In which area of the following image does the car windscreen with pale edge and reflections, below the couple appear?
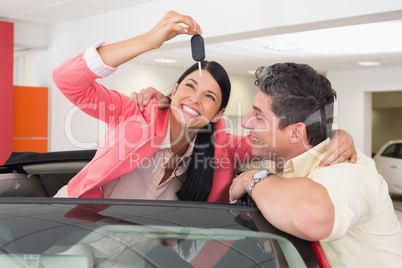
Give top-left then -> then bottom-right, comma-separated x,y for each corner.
70,225 -> 306,268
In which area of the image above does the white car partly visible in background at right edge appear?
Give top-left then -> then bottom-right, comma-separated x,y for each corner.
373,140 -> 402,194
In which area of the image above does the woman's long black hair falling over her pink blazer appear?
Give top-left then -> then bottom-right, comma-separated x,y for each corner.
176,61 -> 231,201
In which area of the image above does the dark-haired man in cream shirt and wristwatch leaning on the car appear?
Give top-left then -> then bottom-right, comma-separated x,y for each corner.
230,63 -> 402,267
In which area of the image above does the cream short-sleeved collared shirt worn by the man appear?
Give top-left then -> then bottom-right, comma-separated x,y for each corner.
271,139 -> 402,268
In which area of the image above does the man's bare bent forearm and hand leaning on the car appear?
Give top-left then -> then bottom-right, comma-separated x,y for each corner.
230,170 -> 335,241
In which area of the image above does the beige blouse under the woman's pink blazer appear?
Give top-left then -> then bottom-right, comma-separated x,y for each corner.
103,118 -> 195,200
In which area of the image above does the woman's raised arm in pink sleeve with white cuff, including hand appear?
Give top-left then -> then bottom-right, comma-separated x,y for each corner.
53,11 -> 201,123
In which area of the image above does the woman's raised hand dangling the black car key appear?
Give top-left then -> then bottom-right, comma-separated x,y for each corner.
145,10 -> 202,49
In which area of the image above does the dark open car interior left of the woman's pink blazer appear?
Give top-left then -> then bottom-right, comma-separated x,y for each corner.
0,150 -> 96,197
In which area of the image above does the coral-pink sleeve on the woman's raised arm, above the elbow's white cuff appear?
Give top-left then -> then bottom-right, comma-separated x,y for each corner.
53,53 -> 137,123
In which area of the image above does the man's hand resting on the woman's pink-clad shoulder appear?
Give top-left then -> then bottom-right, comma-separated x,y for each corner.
131,87 -> 170,112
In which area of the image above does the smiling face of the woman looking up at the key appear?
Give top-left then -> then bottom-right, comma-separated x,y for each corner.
171,70 -> 225,129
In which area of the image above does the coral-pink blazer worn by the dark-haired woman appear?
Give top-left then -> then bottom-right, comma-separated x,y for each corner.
53,51 -> 251,202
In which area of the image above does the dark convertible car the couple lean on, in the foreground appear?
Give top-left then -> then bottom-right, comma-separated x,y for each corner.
0,151 -> 330,268
